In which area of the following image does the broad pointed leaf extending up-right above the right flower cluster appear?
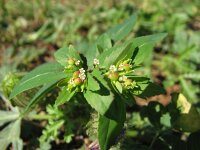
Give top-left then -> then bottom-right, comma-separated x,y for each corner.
98,33 -> 166,67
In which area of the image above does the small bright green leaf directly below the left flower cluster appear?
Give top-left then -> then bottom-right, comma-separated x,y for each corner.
55,87 -> 76,106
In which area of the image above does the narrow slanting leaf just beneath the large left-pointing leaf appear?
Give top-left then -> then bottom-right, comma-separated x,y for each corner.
23,81 -> 57,114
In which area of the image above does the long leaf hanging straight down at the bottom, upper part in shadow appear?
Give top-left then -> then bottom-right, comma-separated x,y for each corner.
98,96 -> 126,150
